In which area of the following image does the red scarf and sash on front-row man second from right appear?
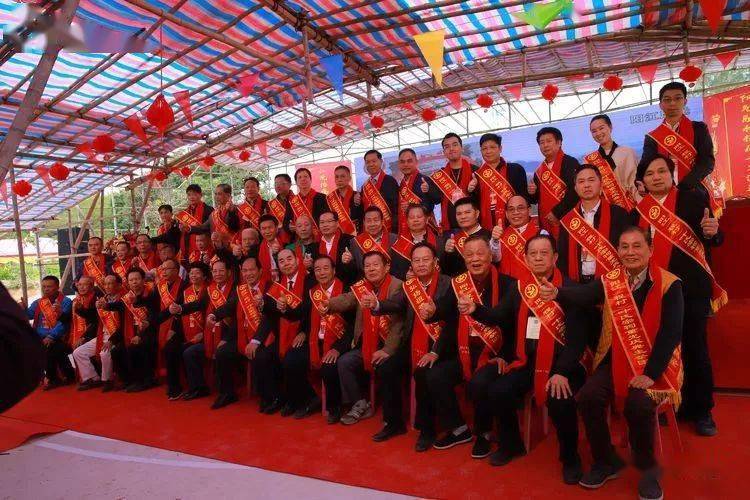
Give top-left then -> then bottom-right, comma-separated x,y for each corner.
509,269 -> 565,404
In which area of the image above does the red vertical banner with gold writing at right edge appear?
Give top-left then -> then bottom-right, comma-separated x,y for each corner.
703,86 -> 750,199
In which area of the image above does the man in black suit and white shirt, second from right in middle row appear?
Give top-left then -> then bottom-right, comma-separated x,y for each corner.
557,164 -> 632,283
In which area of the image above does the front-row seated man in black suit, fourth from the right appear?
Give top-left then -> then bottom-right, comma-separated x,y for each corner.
372,241 -> 453,452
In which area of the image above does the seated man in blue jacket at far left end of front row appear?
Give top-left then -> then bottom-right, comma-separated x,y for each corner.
26,276 -> 76,390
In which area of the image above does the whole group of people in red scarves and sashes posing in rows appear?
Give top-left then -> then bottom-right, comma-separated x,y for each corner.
28,83 -> 726,498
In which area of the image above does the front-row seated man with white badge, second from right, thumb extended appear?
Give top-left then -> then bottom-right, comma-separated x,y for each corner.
458,234 -> 596,484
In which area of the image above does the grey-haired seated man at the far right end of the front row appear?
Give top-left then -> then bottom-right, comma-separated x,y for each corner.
540,227 -> 684,499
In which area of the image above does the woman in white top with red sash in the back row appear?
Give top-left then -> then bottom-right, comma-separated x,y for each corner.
583,115 -> 641,206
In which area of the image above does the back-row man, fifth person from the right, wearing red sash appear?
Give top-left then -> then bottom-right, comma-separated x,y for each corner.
431,132 -> 479,232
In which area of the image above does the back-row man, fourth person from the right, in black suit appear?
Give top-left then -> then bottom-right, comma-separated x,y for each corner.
468,134 -> 530,231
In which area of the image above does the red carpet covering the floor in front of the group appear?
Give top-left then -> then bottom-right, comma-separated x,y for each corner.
0,388 -> 750,499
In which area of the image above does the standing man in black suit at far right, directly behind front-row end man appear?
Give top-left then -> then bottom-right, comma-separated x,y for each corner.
636,155 -> 724,436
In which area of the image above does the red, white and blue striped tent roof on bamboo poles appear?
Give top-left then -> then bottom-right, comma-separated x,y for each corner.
0,0 -> 750,229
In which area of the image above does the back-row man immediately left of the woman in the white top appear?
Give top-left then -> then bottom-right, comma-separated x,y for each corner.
528,127 -> 579,238
